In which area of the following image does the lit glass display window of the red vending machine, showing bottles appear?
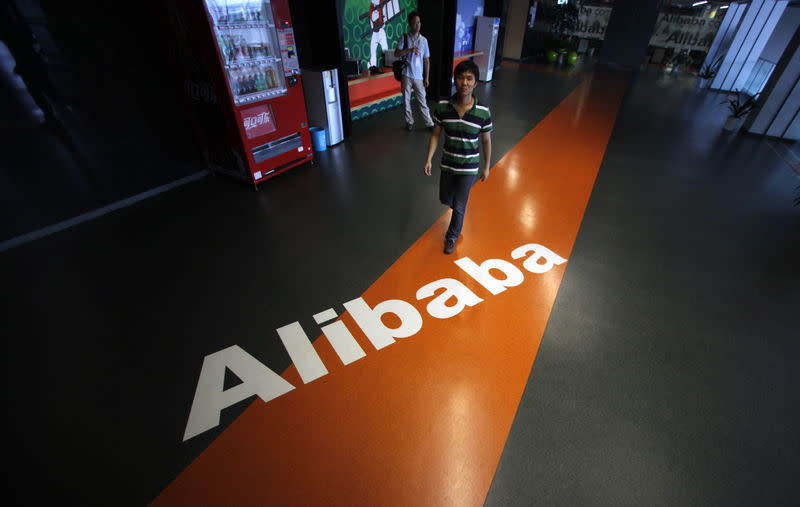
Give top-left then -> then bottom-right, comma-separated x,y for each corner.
205,0 -> 287,106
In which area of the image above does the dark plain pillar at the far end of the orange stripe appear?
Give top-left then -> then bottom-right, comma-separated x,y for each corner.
599,0 -> 664,69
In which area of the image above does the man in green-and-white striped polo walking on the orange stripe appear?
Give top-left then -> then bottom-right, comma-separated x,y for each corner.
424,60 -> 493,254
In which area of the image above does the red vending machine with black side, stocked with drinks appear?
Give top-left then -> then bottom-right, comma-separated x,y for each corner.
166,0 -> 313,185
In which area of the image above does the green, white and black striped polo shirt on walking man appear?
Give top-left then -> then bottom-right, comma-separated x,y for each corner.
433,95 -> 492,174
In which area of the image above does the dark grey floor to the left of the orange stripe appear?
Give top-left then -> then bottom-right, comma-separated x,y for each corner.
0,64 -> 580,505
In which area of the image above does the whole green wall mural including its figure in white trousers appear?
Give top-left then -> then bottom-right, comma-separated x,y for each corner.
342,0 -> 418,69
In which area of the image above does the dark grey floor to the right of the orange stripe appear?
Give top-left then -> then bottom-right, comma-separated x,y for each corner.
486,71 -> 800,505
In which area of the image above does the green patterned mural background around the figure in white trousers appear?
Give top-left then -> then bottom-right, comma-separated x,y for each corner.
342,0 -> 417,67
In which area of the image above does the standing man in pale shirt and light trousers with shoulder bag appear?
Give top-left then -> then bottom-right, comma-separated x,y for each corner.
394,11 -> 433,130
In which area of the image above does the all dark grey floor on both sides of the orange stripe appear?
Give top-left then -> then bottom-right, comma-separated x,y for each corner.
0,68 -> 800,505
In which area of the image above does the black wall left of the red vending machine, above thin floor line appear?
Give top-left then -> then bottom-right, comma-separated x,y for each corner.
0,0 -> 204,240
